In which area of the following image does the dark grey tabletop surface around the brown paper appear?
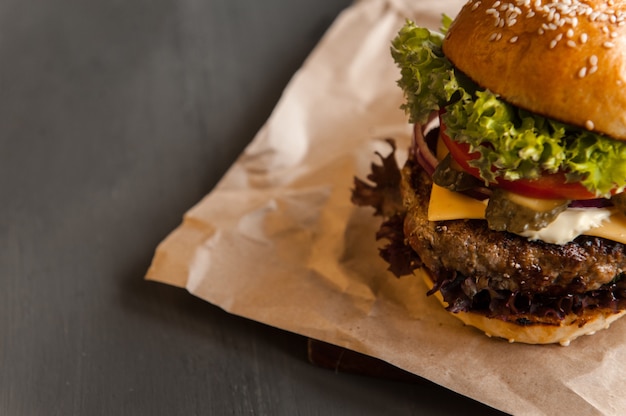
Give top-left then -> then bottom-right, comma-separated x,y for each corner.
0,0 -> 504,416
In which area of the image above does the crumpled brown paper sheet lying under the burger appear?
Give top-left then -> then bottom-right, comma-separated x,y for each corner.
147,0 -> 626,415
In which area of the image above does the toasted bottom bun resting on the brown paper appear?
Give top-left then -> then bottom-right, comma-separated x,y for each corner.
415,268 -> 626,346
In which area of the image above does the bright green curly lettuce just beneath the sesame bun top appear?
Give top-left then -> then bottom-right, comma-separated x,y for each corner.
391,18 -> 626,197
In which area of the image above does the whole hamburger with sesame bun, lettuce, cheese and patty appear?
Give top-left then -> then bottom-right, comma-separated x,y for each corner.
352,0 -> 626,345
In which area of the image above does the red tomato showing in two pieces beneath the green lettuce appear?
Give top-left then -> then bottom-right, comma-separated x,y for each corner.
439,119 -> 597,200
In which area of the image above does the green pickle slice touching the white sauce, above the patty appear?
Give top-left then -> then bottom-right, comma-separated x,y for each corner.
485,189 -> 571,234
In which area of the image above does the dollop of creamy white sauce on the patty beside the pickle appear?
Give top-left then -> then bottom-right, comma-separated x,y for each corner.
520,208 -> 611,244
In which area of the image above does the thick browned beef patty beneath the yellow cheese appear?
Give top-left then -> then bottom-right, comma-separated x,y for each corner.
401,161 -> 626,295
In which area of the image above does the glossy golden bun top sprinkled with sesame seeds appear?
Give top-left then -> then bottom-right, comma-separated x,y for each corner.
443,0 -> 626,140
